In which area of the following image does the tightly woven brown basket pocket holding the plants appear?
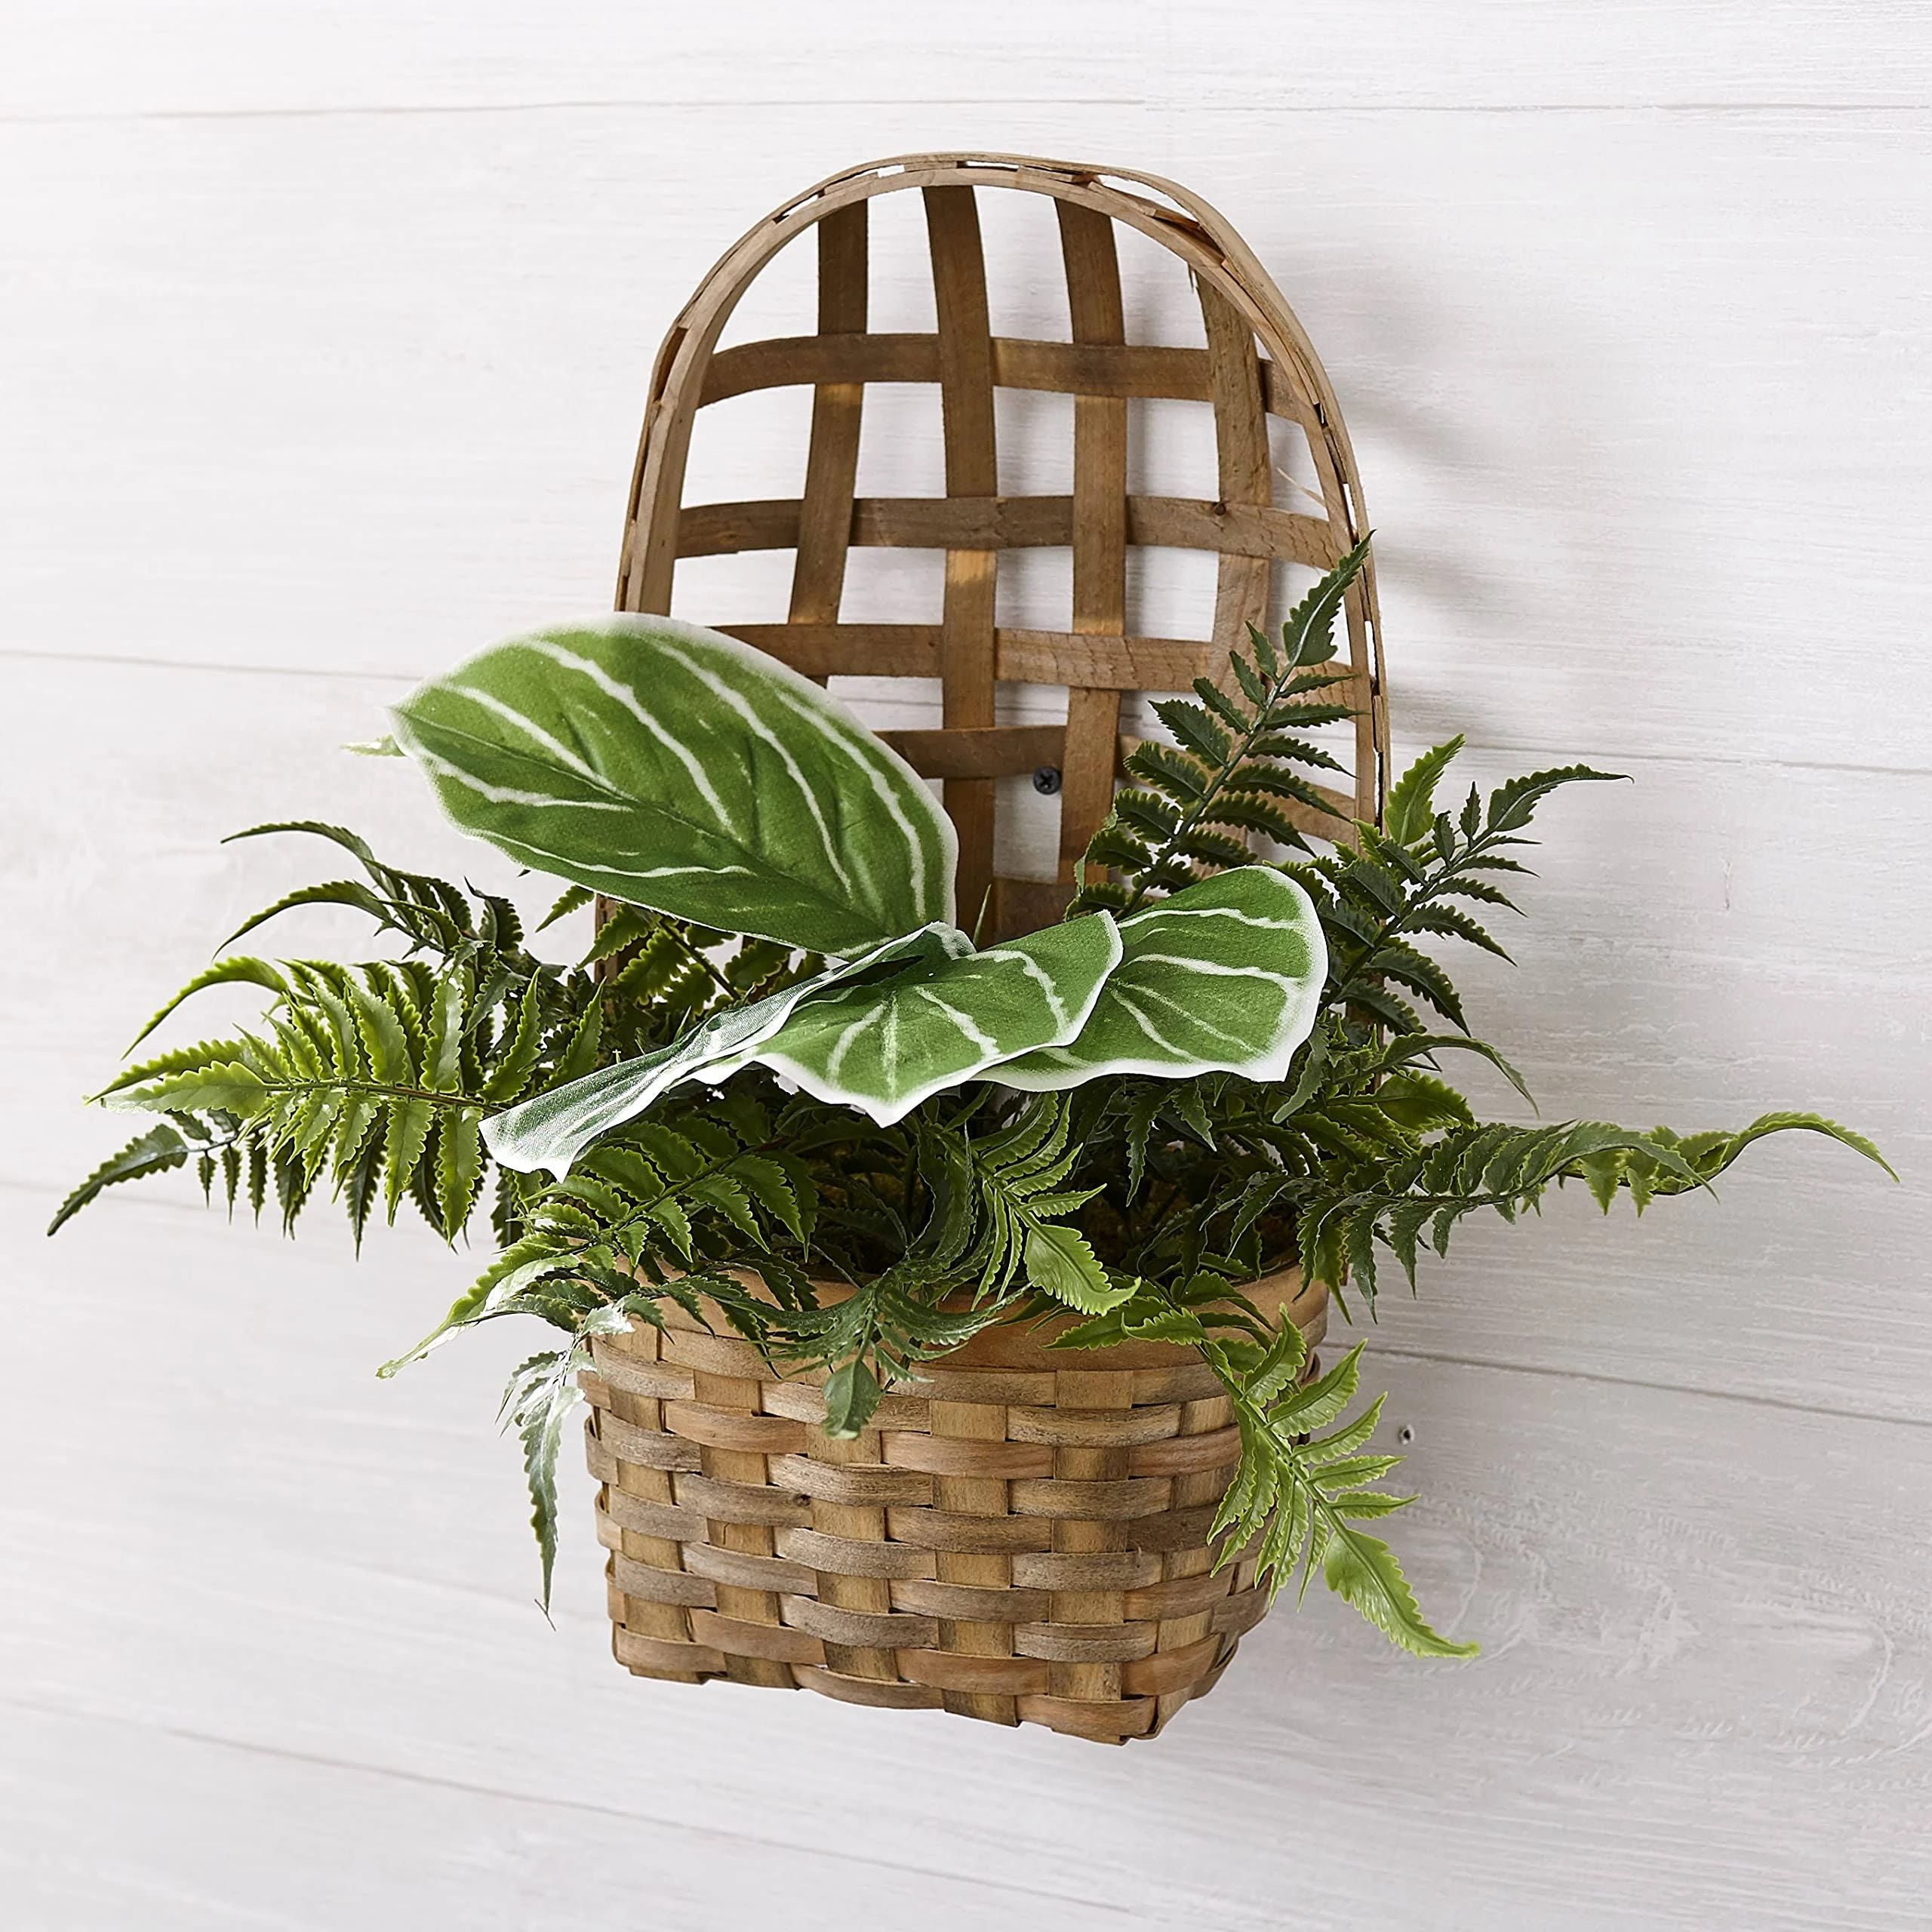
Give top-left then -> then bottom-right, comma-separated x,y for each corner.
583,1273 -> 1325,1743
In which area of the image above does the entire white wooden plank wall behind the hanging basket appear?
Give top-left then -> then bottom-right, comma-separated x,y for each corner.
0,0 -> 1932,1932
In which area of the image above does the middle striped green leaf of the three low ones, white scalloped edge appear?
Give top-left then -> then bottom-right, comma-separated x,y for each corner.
740,912 -> 1121,1126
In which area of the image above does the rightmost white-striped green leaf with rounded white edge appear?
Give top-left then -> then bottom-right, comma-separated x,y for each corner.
995,866 -> 1327,1091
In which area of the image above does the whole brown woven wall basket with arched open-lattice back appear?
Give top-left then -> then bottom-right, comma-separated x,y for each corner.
586,155 -> 1387,1743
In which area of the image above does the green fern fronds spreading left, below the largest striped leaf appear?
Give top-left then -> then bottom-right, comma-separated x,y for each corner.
51,823 -> 819,1244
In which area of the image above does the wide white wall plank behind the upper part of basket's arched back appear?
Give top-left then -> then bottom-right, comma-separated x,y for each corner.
0,106 -> 1932,771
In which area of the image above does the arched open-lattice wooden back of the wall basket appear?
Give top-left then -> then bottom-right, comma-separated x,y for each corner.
617,155 -> 1387,935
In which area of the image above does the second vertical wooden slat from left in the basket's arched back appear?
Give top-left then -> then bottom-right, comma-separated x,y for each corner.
925,187 -> 999,931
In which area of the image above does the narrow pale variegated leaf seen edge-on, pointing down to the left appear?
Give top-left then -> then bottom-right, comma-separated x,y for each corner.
483,924 -> 972,1179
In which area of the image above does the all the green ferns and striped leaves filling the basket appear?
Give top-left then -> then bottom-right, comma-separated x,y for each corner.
54,546 -> 1881,1656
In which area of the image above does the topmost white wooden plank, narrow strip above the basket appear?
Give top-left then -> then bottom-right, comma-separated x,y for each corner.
0,0 -> 1932,117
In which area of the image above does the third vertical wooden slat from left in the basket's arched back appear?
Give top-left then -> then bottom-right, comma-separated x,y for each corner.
1058,201 -> 1126,887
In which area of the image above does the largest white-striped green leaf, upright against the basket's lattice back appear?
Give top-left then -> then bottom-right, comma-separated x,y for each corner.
394,614 -> 956,958
